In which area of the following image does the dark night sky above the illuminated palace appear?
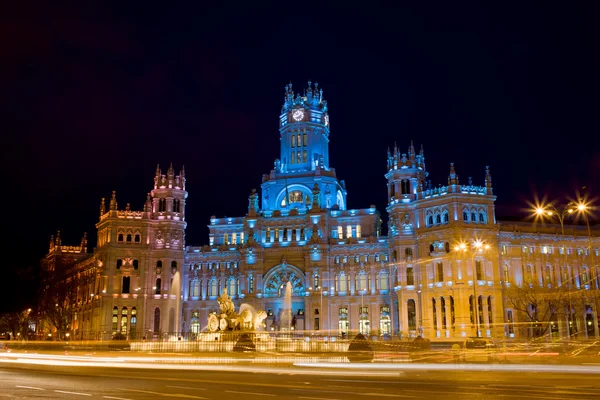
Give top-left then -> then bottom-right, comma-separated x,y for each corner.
0,2 -> 600,310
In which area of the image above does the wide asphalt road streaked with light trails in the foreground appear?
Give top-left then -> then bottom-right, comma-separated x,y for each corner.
0,363 -> 600,400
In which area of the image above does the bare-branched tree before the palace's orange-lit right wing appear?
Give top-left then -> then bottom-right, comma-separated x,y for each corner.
505,284 -> 570,338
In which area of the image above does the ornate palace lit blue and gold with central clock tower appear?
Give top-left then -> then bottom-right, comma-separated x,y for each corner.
46,82 -> 598,340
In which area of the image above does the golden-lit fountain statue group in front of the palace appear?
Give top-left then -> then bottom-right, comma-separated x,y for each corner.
208,288 -> 267,332
